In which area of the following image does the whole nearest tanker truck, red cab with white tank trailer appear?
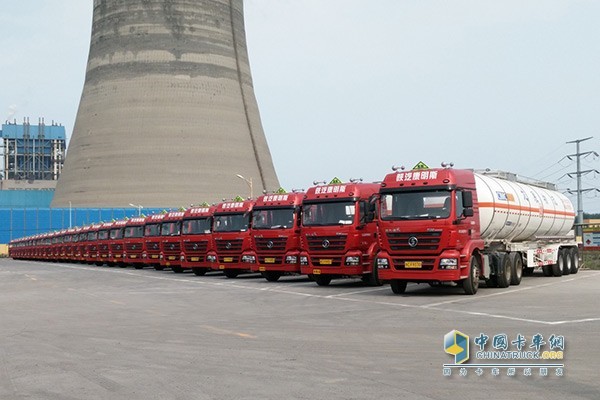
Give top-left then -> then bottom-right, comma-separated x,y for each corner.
377,164 -> 579,294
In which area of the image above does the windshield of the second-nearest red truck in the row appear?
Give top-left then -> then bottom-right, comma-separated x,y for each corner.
302,201 -> 356,226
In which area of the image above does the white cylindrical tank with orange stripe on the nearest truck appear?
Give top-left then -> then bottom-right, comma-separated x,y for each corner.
475,172 -> 575,242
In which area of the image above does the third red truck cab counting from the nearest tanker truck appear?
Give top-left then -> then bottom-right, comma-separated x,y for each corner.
242,193 -> 304,282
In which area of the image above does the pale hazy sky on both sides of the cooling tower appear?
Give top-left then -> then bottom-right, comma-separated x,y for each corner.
0,0 -> 600,212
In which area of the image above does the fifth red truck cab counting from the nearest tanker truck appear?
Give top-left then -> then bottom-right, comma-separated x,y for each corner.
181,206 -> 217,276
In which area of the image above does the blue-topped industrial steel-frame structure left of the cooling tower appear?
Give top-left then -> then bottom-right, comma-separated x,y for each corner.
0,118 -> 66,183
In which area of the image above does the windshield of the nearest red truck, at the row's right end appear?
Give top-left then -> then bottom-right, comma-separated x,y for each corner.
381,190 -> 451,220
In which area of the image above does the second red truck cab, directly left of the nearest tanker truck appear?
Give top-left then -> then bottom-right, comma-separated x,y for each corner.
299,180 -> 380,286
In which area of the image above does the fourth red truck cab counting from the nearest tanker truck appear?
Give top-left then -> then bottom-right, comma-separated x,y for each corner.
213,199 -> 254,278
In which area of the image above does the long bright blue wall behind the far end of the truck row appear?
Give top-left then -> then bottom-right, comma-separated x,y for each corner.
0,208 -> 163,244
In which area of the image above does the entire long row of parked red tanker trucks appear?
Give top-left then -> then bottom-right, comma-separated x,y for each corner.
9,166 -> 579,294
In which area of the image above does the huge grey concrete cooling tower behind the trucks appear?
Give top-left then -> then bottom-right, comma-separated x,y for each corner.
52,0 -> 279,207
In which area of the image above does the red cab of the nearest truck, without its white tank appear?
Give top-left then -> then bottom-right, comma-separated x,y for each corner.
377,169 -> 483,293
